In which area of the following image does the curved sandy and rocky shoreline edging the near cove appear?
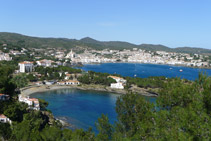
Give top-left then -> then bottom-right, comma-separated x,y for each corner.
20,84 -> 157,97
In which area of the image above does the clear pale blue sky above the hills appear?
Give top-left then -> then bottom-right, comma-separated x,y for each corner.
0,0 -> 211,49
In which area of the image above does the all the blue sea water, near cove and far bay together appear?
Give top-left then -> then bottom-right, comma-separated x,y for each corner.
32,63 -> 211,133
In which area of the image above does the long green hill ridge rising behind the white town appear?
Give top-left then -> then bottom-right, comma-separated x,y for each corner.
0,32 -> 211,53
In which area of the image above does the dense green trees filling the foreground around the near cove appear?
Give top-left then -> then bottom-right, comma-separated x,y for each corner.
0,65 -> 211,140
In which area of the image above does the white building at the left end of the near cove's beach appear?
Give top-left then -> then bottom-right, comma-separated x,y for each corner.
18,95 -> 40,110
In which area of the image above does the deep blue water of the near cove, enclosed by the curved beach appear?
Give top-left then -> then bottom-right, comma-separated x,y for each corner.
32,89 -> 155,132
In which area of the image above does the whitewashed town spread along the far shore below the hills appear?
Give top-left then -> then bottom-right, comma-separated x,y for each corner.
0,44 -> 211,68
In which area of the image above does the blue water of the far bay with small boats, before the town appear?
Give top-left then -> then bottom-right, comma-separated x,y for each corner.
81,63 -> 211,80
